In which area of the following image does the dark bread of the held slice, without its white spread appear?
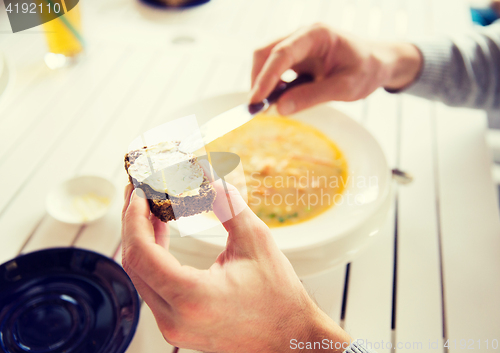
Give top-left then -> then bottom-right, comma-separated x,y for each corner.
125,146 -> 216,222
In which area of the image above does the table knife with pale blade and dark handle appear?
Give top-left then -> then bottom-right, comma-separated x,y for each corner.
179,74 -> 314,153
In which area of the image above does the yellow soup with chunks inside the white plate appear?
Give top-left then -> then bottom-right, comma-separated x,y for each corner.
206,114 -> 347,227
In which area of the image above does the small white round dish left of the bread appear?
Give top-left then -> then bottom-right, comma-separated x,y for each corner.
47,175 -> 116,224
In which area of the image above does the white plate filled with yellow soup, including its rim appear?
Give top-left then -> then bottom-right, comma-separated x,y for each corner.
166,93 -> 392,276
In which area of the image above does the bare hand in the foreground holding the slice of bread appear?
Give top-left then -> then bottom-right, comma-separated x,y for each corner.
122,179 -> 350,353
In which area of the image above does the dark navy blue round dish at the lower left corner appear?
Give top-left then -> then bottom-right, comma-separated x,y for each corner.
0,248 -> 140,353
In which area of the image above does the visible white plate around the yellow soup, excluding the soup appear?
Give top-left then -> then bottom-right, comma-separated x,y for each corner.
166,93 -> 392,275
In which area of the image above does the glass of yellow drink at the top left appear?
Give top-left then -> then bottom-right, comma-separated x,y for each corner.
42,0 -> 84,68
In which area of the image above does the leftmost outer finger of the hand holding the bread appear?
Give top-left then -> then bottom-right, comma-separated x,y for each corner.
122,189 -> 193,302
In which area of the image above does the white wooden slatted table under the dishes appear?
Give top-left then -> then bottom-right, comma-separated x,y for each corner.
0,0 -> 500,353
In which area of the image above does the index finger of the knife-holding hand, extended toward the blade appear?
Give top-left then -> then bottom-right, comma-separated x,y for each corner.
250,25 -> 333,103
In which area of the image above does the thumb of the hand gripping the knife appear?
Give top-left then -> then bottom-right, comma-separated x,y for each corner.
278,73 -> 358,115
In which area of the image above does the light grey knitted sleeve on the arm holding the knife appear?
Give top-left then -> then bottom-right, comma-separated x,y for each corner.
385,24 -> 500,109
